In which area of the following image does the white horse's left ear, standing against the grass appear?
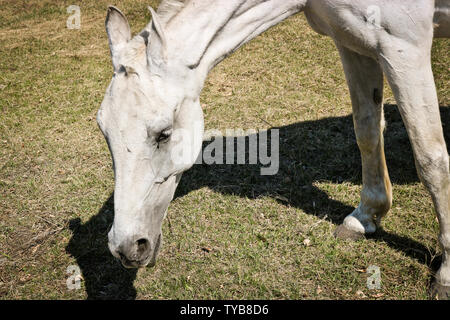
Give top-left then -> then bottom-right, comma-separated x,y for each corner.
105,6 -> 131,69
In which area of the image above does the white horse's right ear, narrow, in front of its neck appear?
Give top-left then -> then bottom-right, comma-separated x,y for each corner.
146,7 -> 167,65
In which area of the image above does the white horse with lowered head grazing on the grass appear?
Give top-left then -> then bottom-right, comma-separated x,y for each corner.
97,0 -> 450,298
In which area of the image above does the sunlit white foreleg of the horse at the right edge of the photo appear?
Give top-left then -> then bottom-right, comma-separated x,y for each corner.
380,40 -> 450,299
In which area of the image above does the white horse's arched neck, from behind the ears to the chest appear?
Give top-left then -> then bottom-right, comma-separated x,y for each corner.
161,0 -> 307,90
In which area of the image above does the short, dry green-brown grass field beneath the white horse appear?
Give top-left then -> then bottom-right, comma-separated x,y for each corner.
0,0 -> 450,299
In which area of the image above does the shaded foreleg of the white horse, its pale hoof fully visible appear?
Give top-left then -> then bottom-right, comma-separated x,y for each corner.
335,46 -> 392,239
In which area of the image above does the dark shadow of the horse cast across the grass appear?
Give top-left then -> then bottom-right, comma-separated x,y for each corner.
66,105 -> 450,299
